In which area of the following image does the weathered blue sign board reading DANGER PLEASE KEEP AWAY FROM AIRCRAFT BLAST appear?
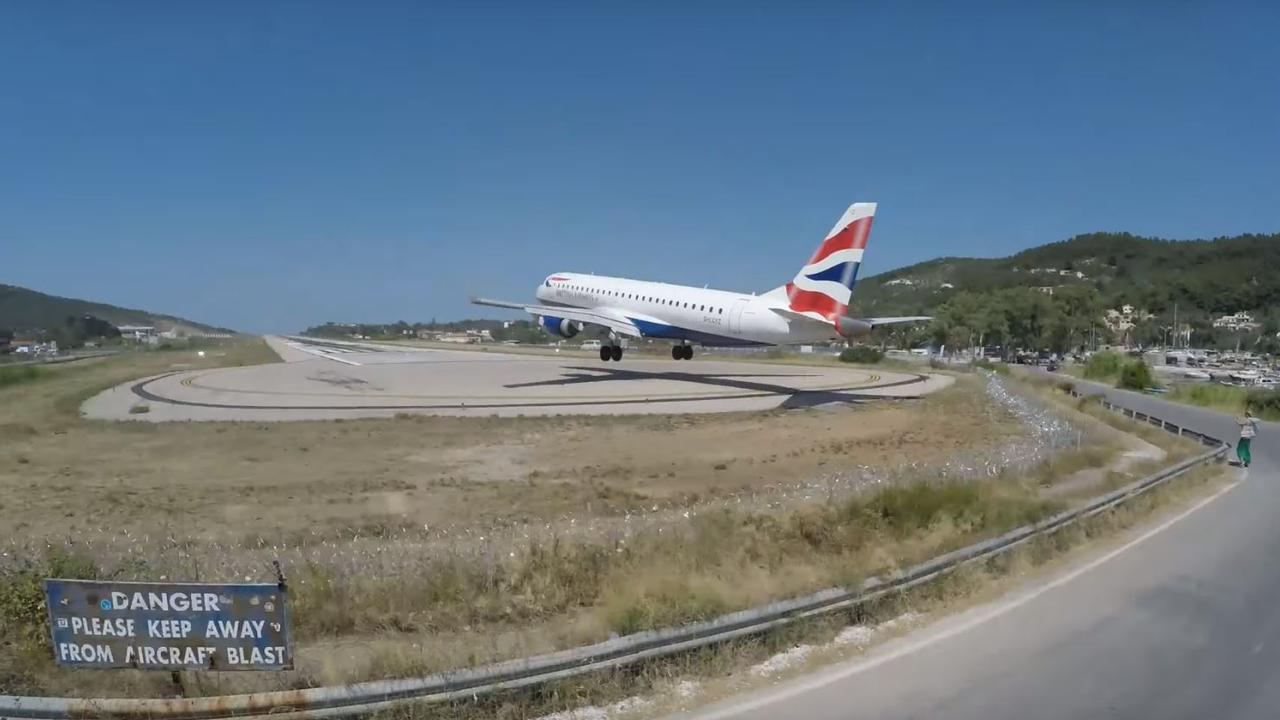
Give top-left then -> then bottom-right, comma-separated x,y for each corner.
45,579 -> 293,670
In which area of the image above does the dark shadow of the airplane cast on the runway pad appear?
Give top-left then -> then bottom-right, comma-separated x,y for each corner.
503,366 -> 924,410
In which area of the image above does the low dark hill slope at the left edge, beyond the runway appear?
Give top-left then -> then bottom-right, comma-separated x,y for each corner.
0,284 -> 232,334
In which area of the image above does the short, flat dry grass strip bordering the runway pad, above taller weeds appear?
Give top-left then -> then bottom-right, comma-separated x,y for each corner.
0,342 -> 1016,541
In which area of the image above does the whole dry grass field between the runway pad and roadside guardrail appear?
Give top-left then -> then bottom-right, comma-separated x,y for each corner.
0,341 -> 1192,696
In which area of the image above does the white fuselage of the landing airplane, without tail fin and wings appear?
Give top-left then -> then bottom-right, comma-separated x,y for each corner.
536,273 -> 840,346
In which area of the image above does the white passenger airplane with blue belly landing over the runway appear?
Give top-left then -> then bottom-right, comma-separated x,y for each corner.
471,202 -> 932,361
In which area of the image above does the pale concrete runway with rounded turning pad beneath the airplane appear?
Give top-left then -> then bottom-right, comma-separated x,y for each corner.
82,337 -> 951,421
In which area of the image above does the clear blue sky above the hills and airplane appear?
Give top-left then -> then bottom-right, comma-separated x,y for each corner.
0,1 -> 1280,331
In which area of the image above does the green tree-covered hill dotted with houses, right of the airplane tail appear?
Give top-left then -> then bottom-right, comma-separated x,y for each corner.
852,233 -> 1280,315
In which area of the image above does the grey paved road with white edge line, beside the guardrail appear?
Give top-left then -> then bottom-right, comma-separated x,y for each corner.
680,388 -> 1280,720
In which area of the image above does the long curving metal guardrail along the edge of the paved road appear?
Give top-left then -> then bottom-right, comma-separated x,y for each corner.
0,391 -> 1229,720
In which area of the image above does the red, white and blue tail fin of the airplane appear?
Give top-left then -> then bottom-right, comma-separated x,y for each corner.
787,202 -> 876,316
